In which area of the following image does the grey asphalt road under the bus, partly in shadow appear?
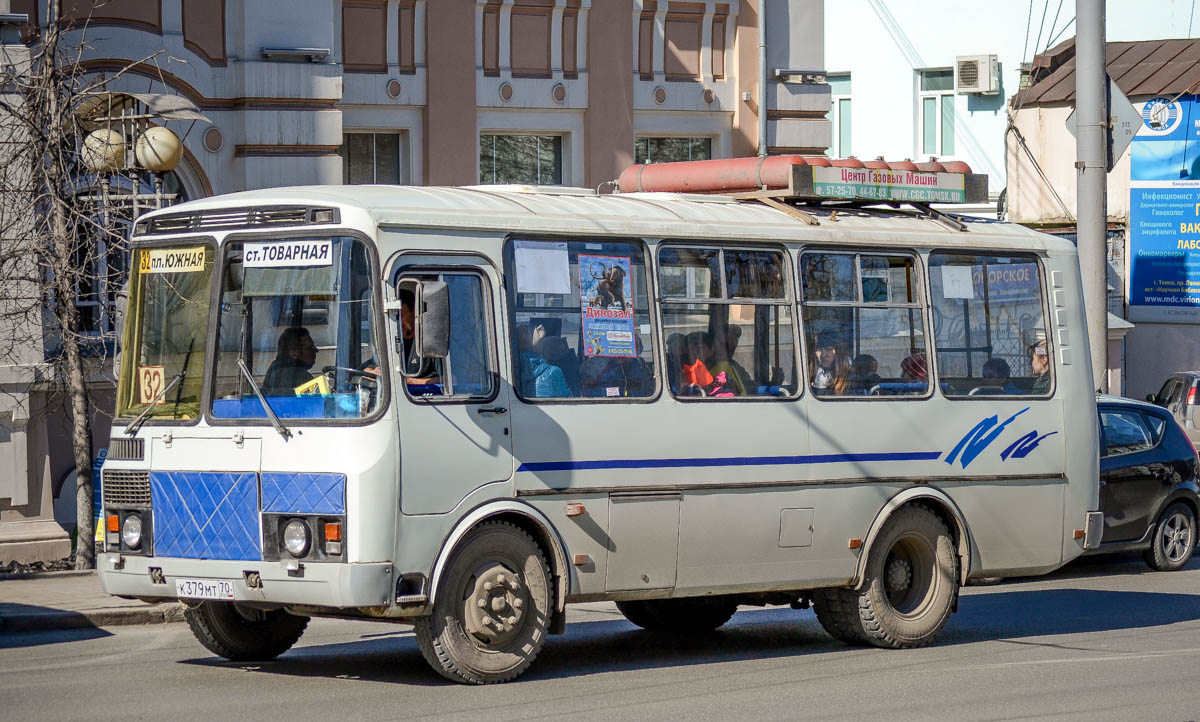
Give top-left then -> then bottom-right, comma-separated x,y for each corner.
0,555 -> 1200,722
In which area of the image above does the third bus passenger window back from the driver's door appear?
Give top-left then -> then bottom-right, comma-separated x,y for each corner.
800,252 -> 930,398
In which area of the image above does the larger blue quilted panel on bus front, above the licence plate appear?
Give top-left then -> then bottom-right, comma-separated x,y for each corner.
150,471 -> 263,561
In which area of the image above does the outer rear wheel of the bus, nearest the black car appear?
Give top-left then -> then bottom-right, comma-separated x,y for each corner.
858,505 -> 959,649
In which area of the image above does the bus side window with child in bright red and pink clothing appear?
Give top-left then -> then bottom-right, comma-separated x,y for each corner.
659,247 -> 797,398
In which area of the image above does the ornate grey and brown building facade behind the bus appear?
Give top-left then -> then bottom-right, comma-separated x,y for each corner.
0,0 -> 830,562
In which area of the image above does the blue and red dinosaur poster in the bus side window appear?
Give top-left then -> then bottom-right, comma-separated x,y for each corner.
580,254 -> 637,359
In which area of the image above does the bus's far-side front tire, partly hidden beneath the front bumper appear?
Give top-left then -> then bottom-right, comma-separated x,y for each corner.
184,602 -> 308,662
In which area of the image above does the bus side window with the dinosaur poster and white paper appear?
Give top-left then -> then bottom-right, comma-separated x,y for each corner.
506,240 -> 658,399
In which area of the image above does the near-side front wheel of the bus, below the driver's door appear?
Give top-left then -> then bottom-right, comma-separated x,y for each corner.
413,522 -> 552,685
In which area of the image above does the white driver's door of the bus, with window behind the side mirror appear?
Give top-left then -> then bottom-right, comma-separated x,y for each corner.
390,255 -> 512,515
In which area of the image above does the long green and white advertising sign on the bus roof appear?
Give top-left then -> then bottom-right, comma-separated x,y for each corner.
812,168 -> 967,203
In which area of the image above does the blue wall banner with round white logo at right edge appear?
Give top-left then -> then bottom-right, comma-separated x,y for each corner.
1129,95 -> 1200,323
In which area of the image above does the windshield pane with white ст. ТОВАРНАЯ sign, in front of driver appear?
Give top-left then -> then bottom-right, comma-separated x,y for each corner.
212,236 -> 380,419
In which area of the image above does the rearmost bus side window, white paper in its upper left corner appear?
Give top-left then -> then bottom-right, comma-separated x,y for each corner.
929,253 -> 1052,397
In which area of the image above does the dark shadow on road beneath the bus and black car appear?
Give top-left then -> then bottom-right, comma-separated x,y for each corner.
185,588 -> 1200,686
